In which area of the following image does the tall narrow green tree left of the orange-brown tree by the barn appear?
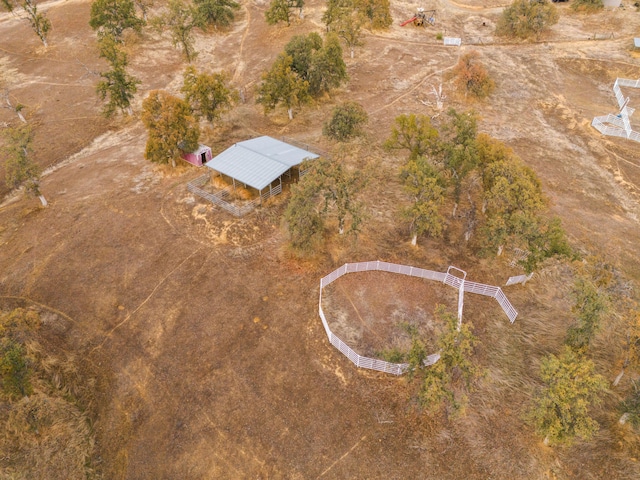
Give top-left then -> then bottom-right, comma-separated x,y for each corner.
96,35 -> 140,117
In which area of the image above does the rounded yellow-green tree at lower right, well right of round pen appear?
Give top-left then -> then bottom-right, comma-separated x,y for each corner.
527,346 -> 607,445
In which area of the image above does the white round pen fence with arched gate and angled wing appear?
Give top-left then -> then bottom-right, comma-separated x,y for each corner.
318,261 -> 518,375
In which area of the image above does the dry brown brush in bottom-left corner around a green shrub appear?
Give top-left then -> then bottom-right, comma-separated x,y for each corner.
0,308 -> 99,479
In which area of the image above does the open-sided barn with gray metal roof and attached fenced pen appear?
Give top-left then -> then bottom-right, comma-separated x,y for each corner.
187,136 -> 320,216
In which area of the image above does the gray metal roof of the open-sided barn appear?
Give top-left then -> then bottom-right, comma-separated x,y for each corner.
205,136 -> 319,190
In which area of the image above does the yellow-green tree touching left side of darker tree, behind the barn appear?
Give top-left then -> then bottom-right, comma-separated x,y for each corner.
256,53 -> 309,120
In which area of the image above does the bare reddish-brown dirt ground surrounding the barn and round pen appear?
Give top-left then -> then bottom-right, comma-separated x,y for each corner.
0,0 -> 640,479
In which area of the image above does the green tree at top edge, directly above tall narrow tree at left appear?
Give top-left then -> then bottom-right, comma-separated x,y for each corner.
89,0 -> 144,42
